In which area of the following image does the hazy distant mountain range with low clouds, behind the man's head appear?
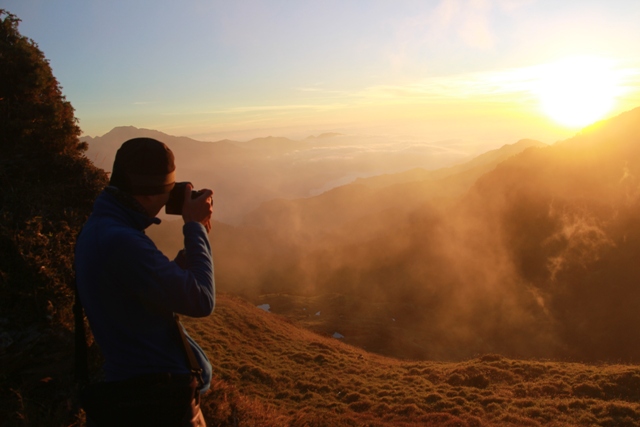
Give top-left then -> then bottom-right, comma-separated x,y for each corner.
82,126 -> 484,224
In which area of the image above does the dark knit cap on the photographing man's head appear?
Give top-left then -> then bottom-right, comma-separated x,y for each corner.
109,138 -> 176,195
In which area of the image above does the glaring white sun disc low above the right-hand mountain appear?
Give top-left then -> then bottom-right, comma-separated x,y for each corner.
536,56 -> 618,128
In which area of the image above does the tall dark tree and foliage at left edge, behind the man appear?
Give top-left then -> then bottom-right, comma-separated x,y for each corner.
0,9 -> 107,426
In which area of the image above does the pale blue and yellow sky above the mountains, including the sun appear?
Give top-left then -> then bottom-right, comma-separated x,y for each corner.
0,0 -> 640,148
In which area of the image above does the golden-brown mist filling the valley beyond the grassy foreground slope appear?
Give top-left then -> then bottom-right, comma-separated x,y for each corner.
110,110 -> 640,362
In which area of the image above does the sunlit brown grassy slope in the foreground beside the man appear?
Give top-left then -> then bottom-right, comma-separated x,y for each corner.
190,295 -> 640,426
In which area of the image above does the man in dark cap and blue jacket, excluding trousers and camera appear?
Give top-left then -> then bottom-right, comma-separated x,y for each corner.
75,138 -> 215,426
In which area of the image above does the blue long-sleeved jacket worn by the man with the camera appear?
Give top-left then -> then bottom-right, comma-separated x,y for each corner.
75,191 -> 215,391
